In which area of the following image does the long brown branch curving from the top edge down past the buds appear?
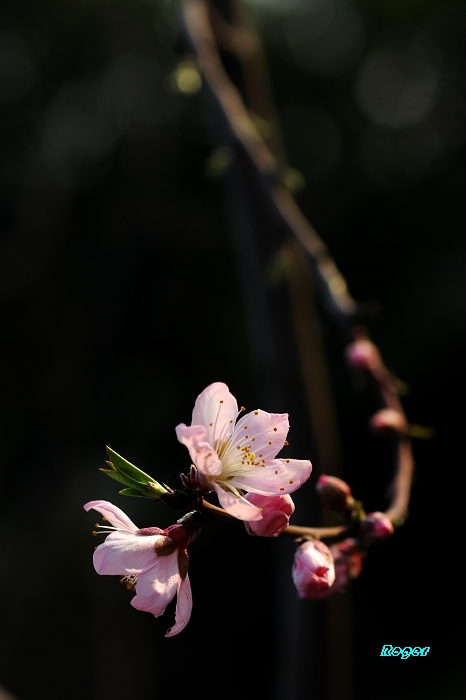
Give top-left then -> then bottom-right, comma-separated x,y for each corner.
183,0 -> 414,530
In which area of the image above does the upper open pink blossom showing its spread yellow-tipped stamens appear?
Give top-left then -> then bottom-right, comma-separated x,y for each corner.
176,382 -> 312,521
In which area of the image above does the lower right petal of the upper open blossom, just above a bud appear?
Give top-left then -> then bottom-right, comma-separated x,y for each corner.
230,459 -> 312,496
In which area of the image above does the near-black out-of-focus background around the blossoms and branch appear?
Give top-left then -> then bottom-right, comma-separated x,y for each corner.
0,0 -> 466,700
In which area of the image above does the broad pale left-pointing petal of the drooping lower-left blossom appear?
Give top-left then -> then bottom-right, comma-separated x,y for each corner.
94,532 -> 163,576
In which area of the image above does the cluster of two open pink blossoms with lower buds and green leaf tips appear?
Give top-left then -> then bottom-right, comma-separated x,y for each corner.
84,382 -> 393,637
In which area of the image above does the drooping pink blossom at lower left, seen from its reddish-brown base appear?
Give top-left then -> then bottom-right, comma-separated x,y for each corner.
84,501 -> 193,637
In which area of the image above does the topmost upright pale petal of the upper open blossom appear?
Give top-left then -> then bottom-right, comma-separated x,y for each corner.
191,382 -> 238,445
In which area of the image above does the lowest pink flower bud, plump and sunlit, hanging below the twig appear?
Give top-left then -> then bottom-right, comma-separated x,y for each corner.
292,540 -> 335,598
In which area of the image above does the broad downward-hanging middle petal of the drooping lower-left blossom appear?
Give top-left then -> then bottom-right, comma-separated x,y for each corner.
131,551 -> 180,617
